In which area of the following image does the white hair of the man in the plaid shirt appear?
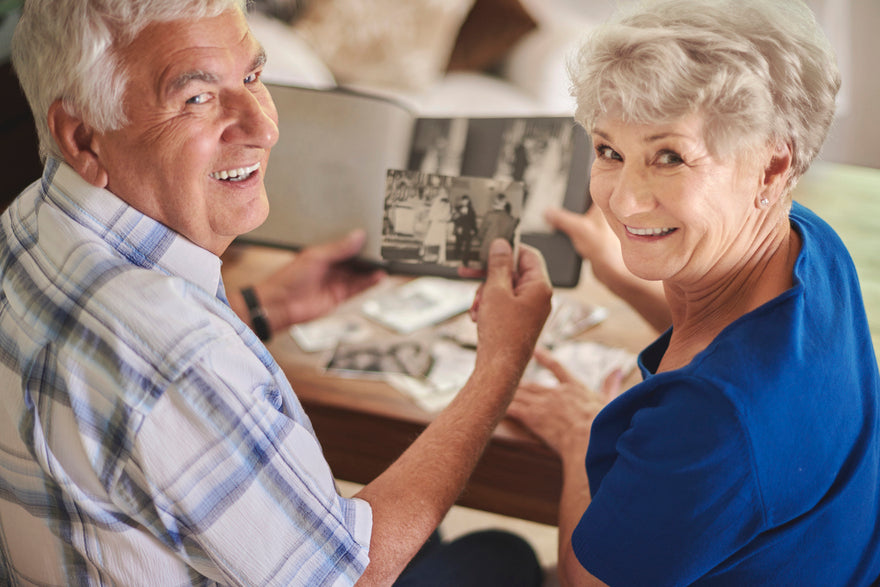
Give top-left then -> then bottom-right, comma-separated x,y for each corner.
12,0 -> 246,159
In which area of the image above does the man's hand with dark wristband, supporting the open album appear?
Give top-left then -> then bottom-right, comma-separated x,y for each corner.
230,230 -> 385,332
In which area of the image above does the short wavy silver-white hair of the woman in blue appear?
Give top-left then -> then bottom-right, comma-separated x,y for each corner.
569,0 -> 840,187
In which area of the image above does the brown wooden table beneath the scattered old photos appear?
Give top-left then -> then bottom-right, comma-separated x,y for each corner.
223,244 -> 655,525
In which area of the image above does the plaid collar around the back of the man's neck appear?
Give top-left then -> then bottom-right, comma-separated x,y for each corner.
43,159 -> 222,294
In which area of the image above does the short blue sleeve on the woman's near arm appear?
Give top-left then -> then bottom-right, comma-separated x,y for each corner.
572,378 -> 764,586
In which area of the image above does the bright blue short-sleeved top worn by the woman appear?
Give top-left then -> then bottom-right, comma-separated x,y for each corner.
572,204 -> 880,587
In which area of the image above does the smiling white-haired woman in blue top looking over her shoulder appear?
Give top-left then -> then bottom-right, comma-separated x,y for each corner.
510,0 -> 880,586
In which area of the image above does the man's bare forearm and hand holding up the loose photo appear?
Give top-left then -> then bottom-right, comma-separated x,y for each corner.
357,239 -> 553,585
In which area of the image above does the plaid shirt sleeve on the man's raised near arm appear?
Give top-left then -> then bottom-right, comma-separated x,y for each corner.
117,334 -> 372,585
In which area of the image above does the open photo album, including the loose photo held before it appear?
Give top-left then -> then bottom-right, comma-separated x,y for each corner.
239,84 -> 591,287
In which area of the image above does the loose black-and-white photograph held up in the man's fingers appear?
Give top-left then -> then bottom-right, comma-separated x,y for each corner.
381,170 -> 524,268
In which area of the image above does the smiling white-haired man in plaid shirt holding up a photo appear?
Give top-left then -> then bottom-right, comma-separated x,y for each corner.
0,0 -> 551,585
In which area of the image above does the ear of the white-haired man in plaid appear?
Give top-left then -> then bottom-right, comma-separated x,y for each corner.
49,99 -> 108,188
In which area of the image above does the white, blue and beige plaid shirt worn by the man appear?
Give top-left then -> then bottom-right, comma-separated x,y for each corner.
0,160 -> 372,586
